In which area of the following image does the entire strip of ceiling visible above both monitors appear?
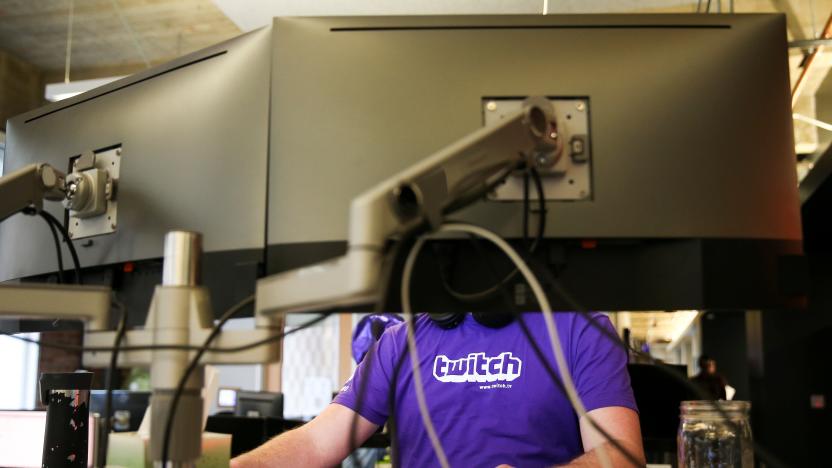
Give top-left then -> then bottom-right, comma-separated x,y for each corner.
0,0 -> 832,78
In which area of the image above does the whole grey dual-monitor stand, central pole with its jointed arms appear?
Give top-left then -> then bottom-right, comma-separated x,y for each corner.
6,98 -> 562,463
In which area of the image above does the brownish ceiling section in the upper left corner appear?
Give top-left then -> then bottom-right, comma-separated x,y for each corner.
0,0 -> 240,78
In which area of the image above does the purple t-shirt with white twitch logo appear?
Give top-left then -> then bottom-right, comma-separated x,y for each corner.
334,313 -> 636,467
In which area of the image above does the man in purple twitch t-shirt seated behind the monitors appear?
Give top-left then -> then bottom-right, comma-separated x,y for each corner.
232,313 -> 644,467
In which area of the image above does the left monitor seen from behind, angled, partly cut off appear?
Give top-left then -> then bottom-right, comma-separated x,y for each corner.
0,29 -> 272,325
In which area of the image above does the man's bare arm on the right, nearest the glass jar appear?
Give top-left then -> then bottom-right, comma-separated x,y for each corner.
566,406 -> 645,468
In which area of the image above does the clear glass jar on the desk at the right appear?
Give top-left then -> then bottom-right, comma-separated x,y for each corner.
676,401 -> 754,468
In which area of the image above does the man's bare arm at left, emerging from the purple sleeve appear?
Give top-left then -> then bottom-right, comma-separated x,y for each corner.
231,403 -> 378,468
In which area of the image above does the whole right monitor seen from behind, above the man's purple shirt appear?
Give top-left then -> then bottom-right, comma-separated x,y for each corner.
267,15 -> 805,310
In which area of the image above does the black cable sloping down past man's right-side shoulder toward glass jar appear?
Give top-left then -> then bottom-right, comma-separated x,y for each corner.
528,259 -> 789,468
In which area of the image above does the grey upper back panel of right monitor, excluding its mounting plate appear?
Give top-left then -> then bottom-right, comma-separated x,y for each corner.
268,15 -> 801,245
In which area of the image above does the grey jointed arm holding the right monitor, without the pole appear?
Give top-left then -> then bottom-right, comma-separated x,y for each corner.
256,97 -> 563,316
